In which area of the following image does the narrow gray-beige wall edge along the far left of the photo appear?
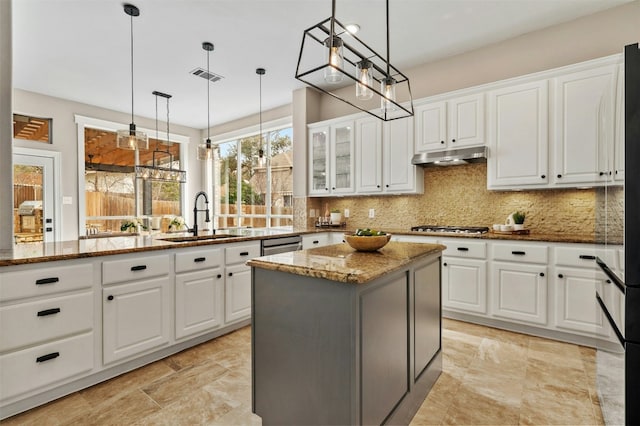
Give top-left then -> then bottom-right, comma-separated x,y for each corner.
0,0 -> 13,255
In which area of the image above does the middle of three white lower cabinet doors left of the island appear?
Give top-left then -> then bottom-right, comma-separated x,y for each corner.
176,268 -> 224,339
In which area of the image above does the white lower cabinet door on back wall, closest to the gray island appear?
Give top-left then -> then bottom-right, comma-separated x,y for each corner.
442,257 -> 487,314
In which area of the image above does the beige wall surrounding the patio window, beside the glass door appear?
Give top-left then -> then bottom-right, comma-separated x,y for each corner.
13,88 -> 204,240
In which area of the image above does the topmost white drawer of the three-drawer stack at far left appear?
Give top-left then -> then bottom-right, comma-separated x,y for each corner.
0,263 -> 93,302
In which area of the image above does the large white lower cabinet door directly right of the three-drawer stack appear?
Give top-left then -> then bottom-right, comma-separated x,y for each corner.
102,277 -> 173,364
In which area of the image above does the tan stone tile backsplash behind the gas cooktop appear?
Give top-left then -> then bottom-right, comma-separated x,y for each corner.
302,163 -> 623,238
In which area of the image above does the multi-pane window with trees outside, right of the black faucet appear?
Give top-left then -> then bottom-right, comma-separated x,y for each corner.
213,127 -> 293,228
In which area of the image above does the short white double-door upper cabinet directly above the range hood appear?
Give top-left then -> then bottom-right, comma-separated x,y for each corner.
415,93 -> 485,152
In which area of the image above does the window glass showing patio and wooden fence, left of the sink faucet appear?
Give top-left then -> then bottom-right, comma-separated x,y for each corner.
84,127 -> 182,235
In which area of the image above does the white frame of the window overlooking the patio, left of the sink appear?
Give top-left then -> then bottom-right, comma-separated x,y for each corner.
74,114 -> 190,236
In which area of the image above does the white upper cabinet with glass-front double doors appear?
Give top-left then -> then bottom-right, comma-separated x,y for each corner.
309,120 -> 355,196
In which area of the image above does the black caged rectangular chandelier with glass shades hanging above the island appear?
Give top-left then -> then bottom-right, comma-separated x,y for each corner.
296,0 -> 413,121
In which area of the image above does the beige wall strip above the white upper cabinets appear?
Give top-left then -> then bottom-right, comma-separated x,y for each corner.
319,0 -> 640,120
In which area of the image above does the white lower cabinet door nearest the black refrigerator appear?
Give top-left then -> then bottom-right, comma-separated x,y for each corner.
556,268 -> 615,337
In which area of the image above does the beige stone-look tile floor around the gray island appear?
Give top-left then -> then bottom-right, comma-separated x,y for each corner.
2,320 -> 604,426
